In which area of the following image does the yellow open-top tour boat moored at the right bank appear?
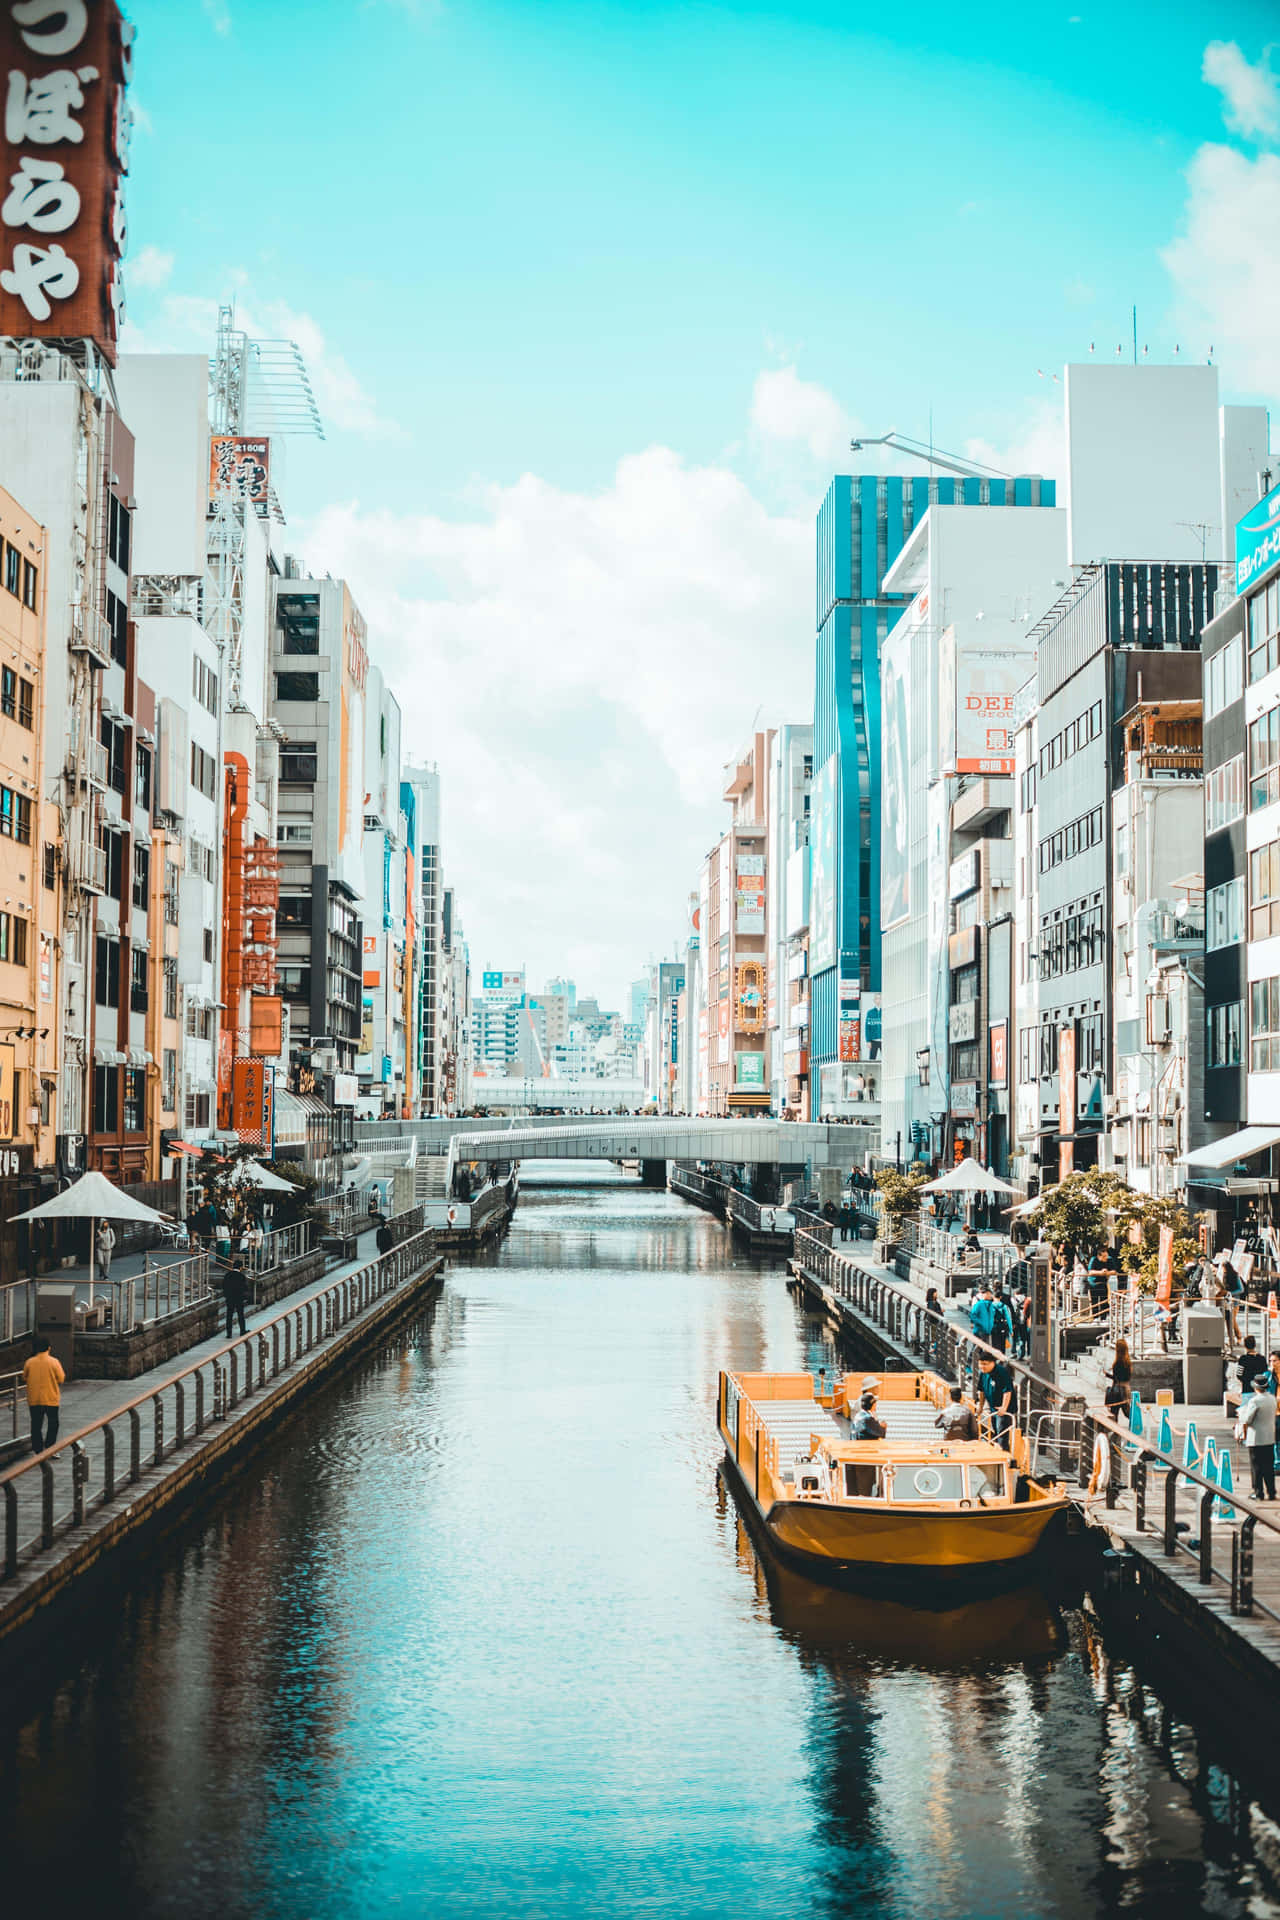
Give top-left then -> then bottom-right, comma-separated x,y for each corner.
718,1373 -> 1067,1584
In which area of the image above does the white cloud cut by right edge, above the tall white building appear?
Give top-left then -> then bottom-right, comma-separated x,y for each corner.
1161,146 -> 1280,397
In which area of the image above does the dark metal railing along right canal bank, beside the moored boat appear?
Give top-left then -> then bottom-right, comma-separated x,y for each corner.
796,1233 -> 1280,1622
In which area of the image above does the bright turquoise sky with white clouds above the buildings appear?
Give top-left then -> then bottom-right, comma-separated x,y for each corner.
129,0 -> 1280,993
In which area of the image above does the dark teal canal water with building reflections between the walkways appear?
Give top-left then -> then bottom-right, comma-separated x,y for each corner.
0,1165 -> 1280,1920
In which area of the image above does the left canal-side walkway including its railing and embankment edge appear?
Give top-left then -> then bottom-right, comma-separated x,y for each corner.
0,1229 -> 443,1638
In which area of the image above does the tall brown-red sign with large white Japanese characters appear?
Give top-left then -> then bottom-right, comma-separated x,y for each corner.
0,0 -> 132,365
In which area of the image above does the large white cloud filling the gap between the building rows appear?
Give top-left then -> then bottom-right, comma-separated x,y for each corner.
303,447 -> 814,1004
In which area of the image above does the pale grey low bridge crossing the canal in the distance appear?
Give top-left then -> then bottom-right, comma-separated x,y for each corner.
355,1110 -> 879,1171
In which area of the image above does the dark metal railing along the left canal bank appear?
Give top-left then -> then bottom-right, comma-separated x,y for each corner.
0,1233 -> 434,1580
